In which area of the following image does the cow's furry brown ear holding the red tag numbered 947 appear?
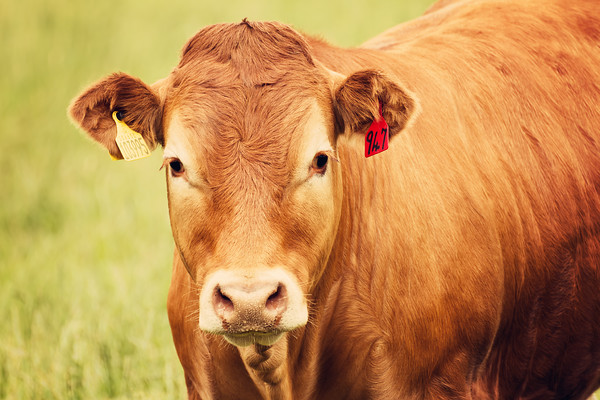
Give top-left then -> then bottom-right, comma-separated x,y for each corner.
334,70 -> 417,137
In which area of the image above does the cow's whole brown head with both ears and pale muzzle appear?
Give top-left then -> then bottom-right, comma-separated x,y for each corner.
70,21 -> 414,346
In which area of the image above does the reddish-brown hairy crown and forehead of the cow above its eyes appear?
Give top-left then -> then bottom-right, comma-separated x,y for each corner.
165,20 -> 331,171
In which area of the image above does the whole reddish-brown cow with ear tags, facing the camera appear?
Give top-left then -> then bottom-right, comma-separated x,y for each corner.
70,0 -> 600,399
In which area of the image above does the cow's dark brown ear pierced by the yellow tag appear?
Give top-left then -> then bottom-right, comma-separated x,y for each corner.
69,73 -> 163,159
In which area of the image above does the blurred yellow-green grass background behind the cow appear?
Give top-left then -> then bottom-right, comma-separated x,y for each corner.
0,0 -> 433,399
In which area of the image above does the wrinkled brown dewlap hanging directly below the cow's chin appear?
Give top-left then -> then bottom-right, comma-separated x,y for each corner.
238,335 -> 292,400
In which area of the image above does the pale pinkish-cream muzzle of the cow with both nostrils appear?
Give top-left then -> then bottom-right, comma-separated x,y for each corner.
199,269 -> 308,347
